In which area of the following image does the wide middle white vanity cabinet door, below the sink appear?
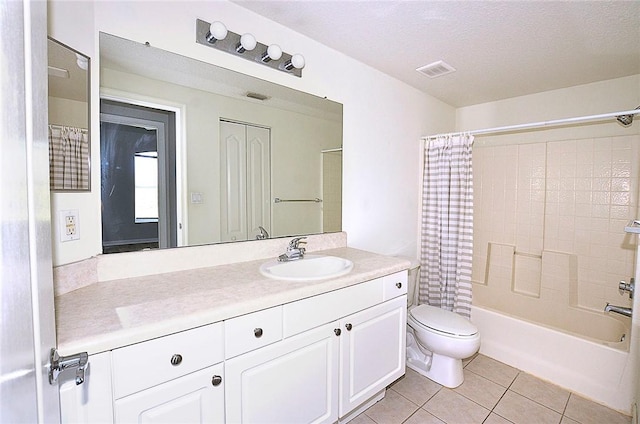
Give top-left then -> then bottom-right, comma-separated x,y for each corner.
225,322 -> 340,424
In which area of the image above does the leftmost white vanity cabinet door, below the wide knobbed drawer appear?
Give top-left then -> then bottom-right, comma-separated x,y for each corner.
115,364 -> 224,424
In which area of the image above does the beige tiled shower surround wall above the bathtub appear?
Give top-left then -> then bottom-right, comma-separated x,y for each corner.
473,135 -> 640,310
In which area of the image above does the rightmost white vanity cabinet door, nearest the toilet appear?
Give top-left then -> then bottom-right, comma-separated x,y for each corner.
340,295 -> 407,417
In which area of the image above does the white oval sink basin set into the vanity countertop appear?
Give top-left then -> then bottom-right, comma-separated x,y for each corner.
260,255 -> 353,281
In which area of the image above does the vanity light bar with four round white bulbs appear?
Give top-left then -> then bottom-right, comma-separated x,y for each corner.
196,19 -> 305,77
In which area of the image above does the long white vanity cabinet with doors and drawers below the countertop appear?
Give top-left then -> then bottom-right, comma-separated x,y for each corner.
60,271 -> 407,424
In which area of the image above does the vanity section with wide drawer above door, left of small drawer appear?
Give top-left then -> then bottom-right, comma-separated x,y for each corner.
112,322 -> 224,423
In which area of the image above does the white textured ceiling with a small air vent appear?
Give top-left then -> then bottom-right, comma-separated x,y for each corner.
232,0 -> 640,107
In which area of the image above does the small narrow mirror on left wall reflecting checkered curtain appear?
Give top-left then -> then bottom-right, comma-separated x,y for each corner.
47,38 -> 91,191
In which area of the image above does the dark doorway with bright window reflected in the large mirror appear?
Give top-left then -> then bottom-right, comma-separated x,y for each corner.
100,101 -> 176,253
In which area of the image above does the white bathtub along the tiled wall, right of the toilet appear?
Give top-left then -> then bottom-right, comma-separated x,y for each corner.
471,305 -> 636,415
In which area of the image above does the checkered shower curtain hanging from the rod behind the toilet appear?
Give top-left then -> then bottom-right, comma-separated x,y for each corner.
419,135 -> 473,318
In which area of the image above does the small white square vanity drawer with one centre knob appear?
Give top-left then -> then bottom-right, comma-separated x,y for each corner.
224,306 -> 282,359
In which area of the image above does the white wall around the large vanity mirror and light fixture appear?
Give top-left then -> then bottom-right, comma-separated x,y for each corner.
49,0 -> 455,265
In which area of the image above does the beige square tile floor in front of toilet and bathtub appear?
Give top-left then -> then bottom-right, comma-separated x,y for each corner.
351,355 -> 631,424
